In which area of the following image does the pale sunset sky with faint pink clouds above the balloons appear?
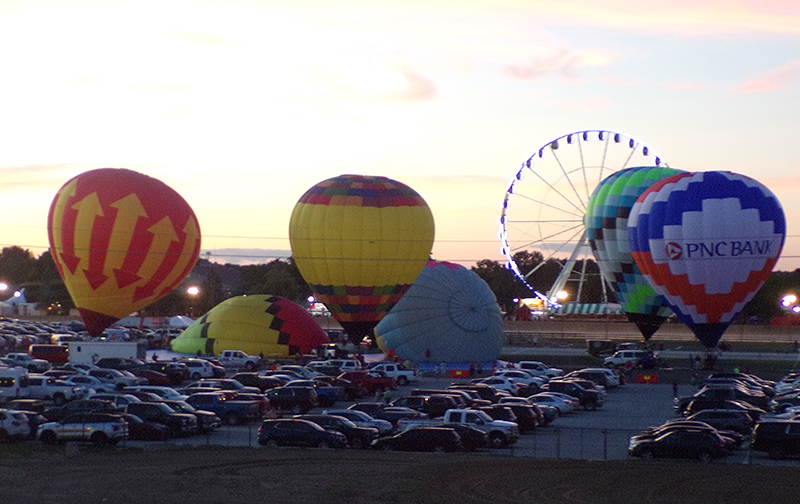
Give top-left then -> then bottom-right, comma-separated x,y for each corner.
0,0 -> 800,276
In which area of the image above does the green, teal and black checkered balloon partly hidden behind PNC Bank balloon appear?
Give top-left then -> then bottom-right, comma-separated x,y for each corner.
584,166 -> 684,340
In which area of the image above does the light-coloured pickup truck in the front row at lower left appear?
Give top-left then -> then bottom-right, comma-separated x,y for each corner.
36,413 -> 128,445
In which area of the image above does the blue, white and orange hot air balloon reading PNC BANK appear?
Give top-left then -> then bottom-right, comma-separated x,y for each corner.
628,171 -> 786,348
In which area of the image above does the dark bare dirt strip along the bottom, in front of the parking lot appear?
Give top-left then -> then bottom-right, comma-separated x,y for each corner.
0,445 -> 800,504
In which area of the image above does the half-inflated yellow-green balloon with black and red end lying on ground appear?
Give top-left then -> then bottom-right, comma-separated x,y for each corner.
171,295 -> 329,357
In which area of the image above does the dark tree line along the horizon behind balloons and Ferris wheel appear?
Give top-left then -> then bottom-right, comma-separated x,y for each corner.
0,246 -> 800,321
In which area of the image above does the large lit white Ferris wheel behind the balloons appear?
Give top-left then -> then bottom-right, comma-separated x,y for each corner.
500,130 -> 667,306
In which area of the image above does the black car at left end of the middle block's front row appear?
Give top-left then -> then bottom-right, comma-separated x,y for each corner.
258,418 -> 347,448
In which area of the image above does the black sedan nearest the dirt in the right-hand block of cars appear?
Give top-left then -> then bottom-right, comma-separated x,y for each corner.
628,430 -> 730,462
